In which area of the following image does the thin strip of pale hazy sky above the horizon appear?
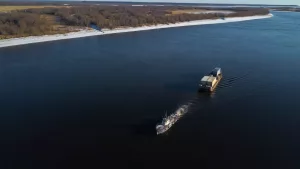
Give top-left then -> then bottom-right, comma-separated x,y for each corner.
72,0 -> 300,5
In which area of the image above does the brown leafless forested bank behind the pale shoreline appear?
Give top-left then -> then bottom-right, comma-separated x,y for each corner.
0,6 -> 269,38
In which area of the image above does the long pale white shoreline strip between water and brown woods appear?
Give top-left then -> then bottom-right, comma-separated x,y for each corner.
0,14 -> 273,48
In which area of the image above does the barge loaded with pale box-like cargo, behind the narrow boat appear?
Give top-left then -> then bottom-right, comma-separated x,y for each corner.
199,67 -> 222,92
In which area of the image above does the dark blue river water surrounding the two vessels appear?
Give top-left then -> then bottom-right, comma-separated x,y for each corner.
0,13 -> 300,169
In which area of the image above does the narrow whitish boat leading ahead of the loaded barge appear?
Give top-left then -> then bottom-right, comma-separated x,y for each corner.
156,105 -> 189,135
